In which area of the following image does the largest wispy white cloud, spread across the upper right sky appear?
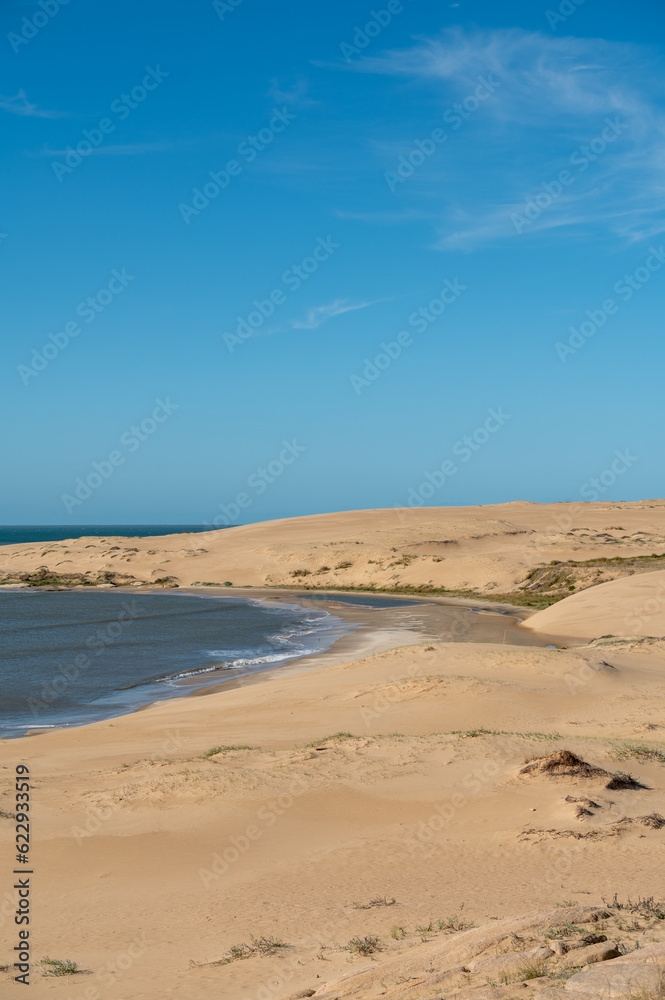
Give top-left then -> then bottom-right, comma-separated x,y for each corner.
353,28 -> 665,250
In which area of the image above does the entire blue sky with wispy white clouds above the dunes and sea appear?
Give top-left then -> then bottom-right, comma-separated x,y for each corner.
0,0 -> 665,524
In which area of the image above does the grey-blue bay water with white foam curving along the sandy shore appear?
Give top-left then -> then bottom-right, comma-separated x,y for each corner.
0,590 -> 344,736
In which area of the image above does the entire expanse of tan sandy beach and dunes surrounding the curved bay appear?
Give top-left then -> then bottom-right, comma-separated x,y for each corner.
0,501 -> 665,1000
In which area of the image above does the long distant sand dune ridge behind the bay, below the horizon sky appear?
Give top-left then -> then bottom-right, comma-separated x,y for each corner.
0,500 -> 665,594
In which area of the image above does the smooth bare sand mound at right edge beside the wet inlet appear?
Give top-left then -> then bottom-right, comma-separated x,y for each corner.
521,570 -> 665,641
